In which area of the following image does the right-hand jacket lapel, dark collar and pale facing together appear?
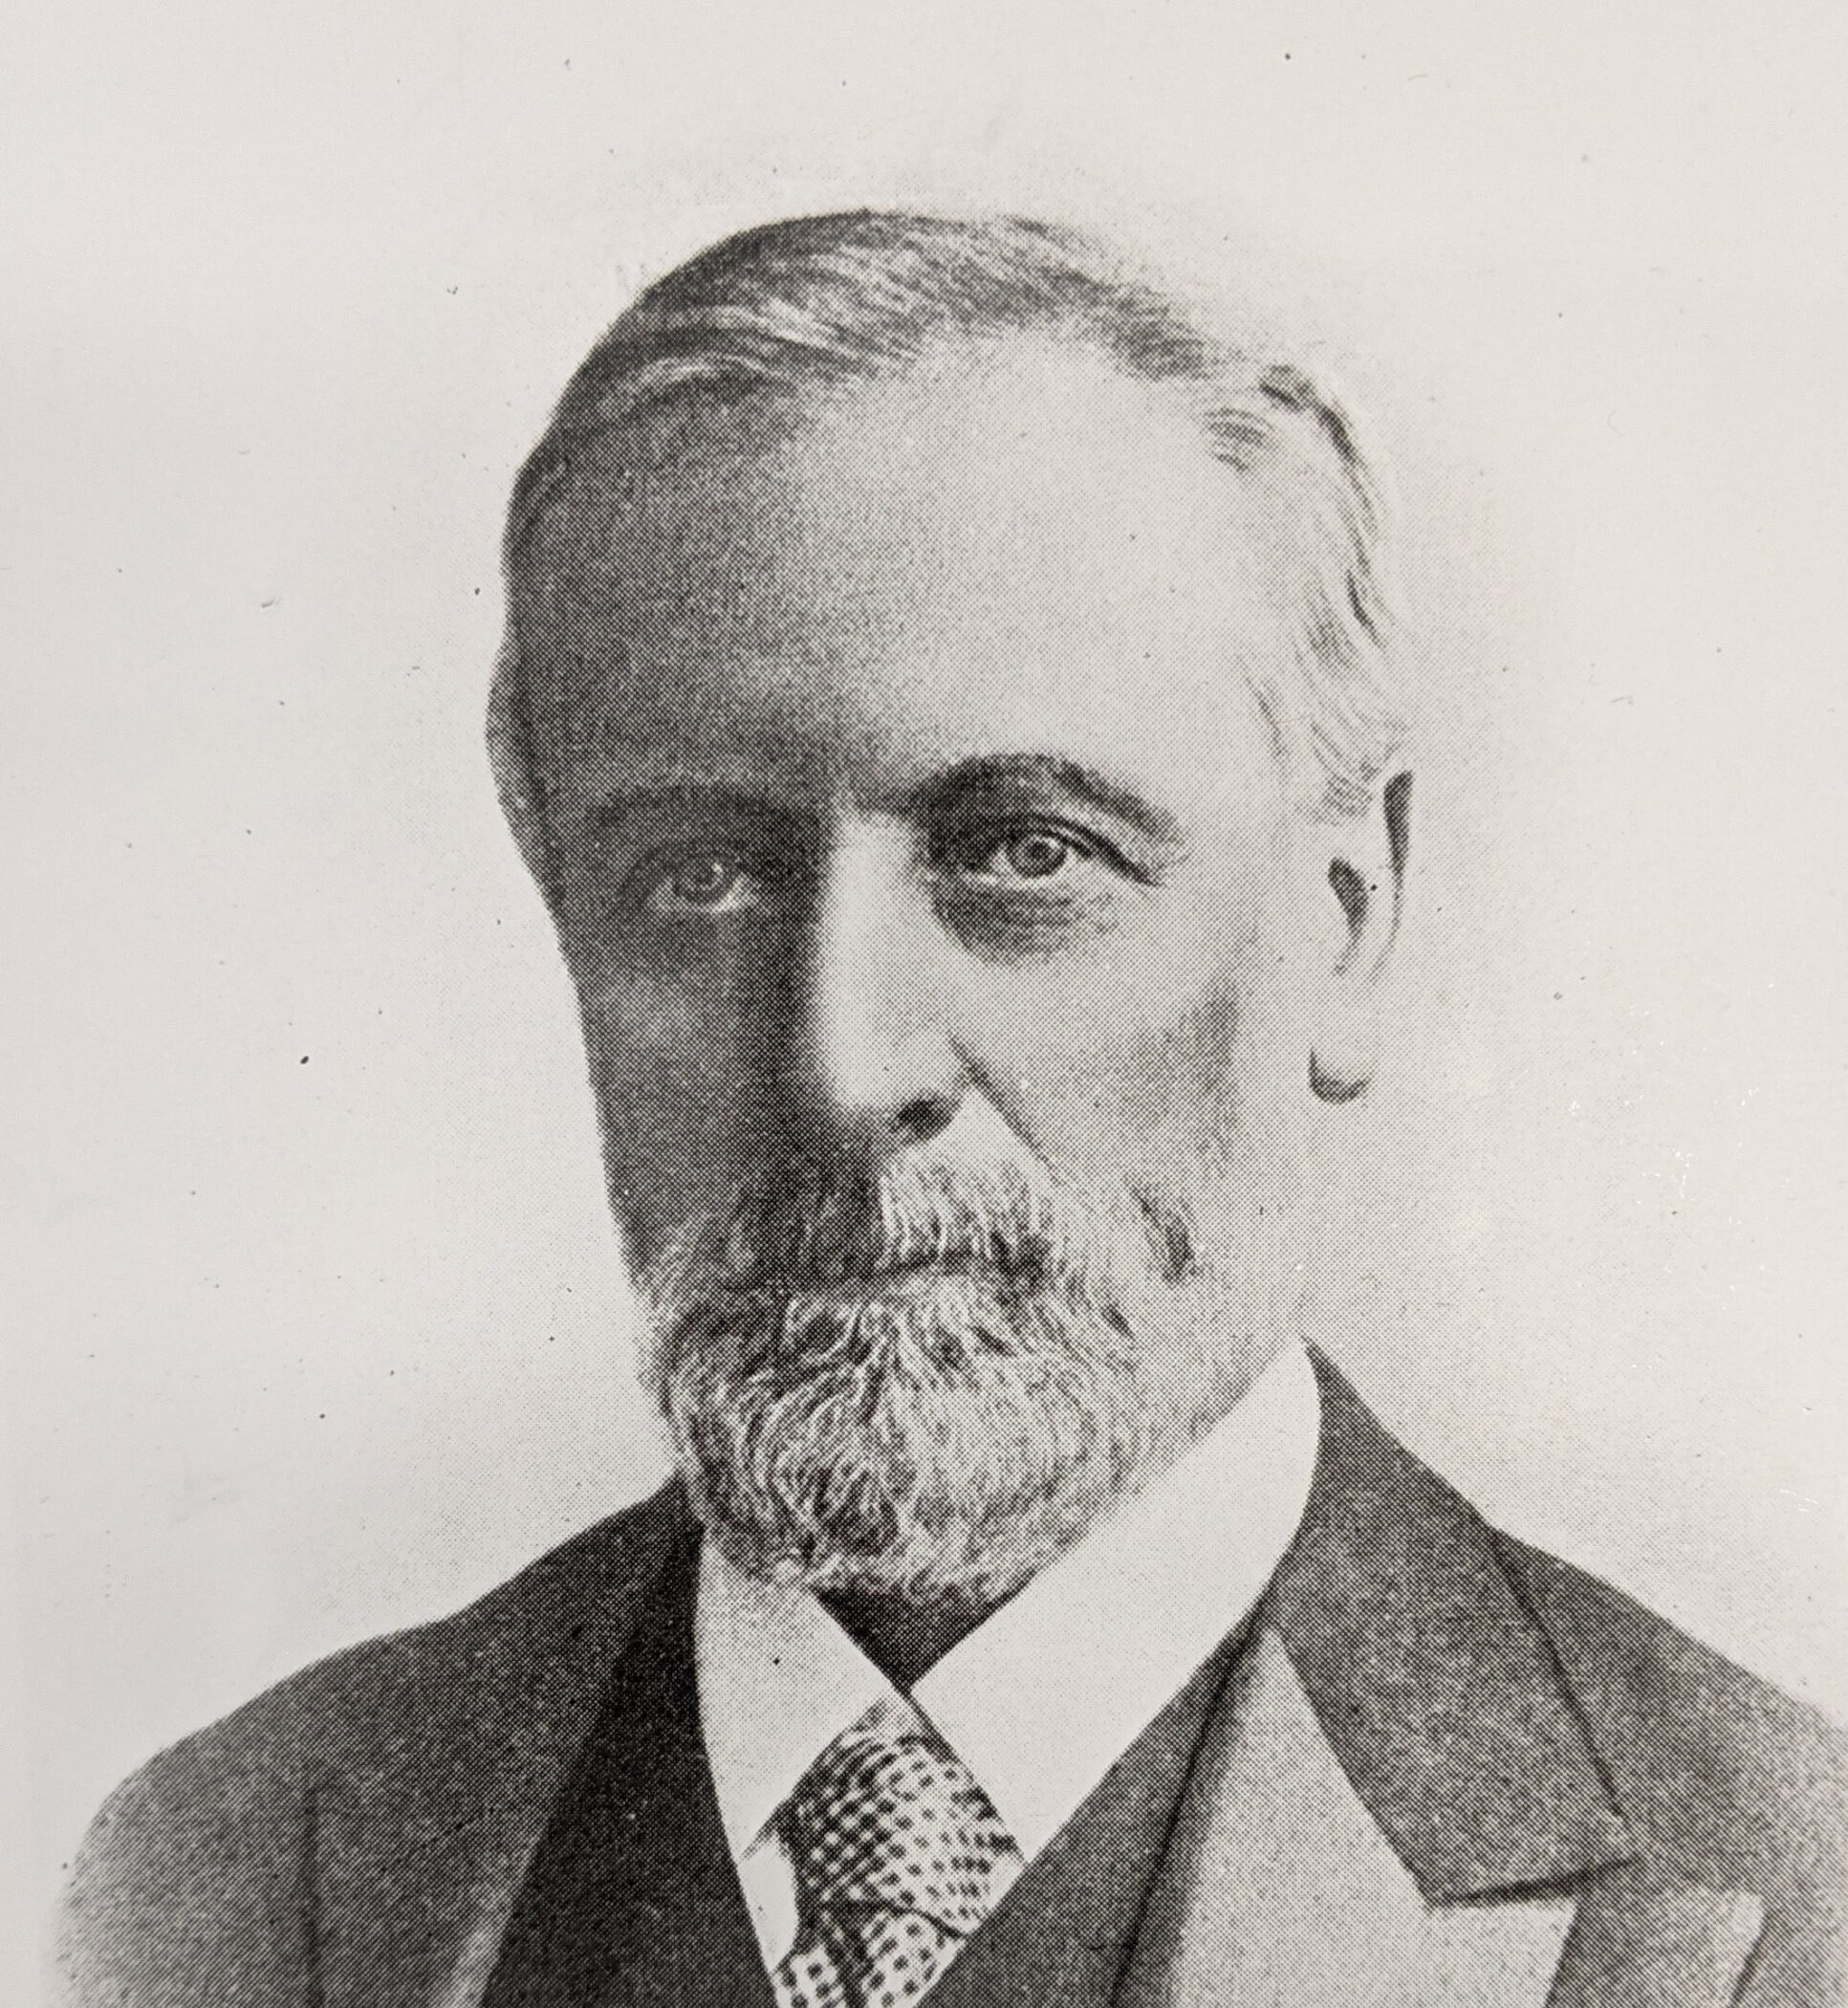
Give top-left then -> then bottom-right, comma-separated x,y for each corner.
1125,1358 -> 1762,2008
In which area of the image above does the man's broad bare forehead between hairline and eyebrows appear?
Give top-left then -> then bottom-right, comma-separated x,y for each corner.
514,341 -> 1290,794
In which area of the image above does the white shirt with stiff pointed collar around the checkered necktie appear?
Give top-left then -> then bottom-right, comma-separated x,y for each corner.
695,1345 -> 1322,1968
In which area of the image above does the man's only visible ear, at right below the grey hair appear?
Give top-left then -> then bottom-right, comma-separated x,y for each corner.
1310,774 -> 1412,1102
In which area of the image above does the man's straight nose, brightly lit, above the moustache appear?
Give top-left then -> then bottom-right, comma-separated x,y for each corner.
795,818 -> 967,1159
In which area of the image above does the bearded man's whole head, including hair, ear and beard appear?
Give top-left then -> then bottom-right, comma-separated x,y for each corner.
492,215 -> 1404,1603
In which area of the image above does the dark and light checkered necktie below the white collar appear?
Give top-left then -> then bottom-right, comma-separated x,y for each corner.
772,1703 -> 1020,2008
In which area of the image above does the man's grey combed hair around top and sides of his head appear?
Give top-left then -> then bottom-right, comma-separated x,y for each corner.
489,211 -> 1404,889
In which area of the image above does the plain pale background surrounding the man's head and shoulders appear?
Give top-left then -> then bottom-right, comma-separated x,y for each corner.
0,0 -> 1848,2000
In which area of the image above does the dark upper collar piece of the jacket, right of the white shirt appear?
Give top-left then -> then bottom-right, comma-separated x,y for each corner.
1268,1353 -> 1637,1904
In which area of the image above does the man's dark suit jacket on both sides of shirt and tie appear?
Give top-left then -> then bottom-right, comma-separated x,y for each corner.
62,1362 -> 1848,2008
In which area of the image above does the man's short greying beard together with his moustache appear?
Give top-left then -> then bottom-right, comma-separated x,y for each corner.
642,1163 -> 1177,1606
